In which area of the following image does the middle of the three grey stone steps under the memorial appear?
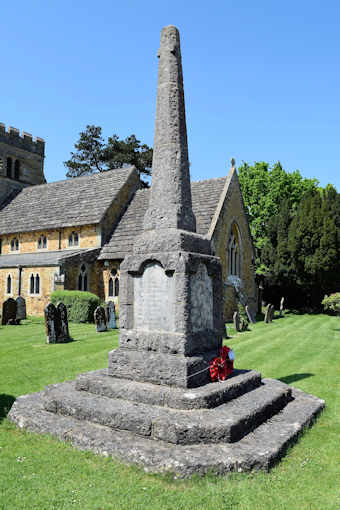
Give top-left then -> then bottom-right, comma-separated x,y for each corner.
45,379 -> 291,444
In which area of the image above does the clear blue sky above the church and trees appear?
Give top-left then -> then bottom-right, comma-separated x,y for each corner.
0,0 -> 340,191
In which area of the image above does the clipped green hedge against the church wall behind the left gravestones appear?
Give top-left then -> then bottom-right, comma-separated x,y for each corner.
51,290 -> 101,322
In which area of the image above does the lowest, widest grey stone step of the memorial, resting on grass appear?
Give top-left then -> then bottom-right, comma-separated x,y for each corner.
8,389 -> 325,478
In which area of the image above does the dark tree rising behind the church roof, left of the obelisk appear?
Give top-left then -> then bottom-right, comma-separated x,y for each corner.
64,125 -> 152,186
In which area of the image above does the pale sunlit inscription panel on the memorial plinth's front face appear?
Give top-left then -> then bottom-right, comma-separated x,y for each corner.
134,262 -> 175,332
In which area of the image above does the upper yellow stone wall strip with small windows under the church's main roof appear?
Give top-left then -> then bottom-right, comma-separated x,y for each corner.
1,225 -> 101,255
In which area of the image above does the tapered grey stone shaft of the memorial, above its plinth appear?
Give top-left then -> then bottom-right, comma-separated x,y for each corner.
144,26 -> 196,232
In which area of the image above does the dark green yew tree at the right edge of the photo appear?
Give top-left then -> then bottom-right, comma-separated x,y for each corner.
261,185 -> 340,310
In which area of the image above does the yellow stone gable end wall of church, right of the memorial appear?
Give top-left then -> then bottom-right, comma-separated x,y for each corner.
212,173 -> 257,320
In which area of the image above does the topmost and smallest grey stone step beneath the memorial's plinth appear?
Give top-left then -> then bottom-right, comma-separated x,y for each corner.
76,369 -> 261,409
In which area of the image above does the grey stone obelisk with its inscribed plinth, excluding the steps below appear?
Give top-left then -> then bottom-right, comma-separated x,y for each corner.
108,26 -> 223,388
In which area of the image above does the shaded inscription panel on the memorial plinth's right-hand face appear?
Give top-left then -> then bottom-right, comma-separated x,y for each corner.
190,263 -> 213,333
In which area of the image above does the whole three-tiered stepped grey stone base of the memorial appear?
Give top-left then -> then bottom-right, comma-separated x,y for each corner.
8,369 -> 325,477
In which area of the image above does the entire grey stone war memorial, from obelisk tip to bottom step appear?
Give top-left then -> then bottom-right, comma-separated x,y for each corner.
9,26 -> 324,477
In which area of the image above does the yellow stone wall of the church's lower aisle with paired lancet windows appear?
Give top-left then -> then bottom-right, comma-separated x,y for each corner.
0,266 -> 58,315
